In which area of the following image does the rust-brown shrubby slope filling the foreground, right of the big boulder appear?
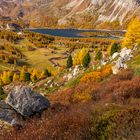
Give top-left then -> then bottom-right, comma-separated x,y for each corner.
0,70 -> 140,140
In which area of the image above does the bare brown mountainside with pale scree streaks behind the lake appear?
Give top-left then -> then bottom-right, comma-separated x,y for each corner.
0,0 -> 140,26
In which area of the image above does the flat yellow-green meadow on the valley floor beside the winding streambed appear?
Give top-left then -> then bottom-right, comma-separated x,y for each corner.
23,48 -> 66,70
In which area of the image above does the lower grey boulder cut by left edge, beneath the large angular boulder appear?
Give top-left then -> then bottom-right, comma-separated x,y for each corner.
0,101 -> 22,127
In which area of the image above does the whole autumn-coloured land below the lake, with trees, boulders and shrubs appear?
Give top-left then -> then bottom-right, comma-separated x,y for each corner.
0,18 -> 140,140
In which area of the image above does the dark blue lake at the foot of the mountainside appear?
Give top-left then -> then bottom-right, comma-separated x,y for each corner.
29,29 -> 125,39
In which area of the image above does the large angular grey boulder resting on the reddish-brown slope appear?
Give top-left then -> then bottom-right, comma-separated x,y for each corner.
6,86 -> 49,117
